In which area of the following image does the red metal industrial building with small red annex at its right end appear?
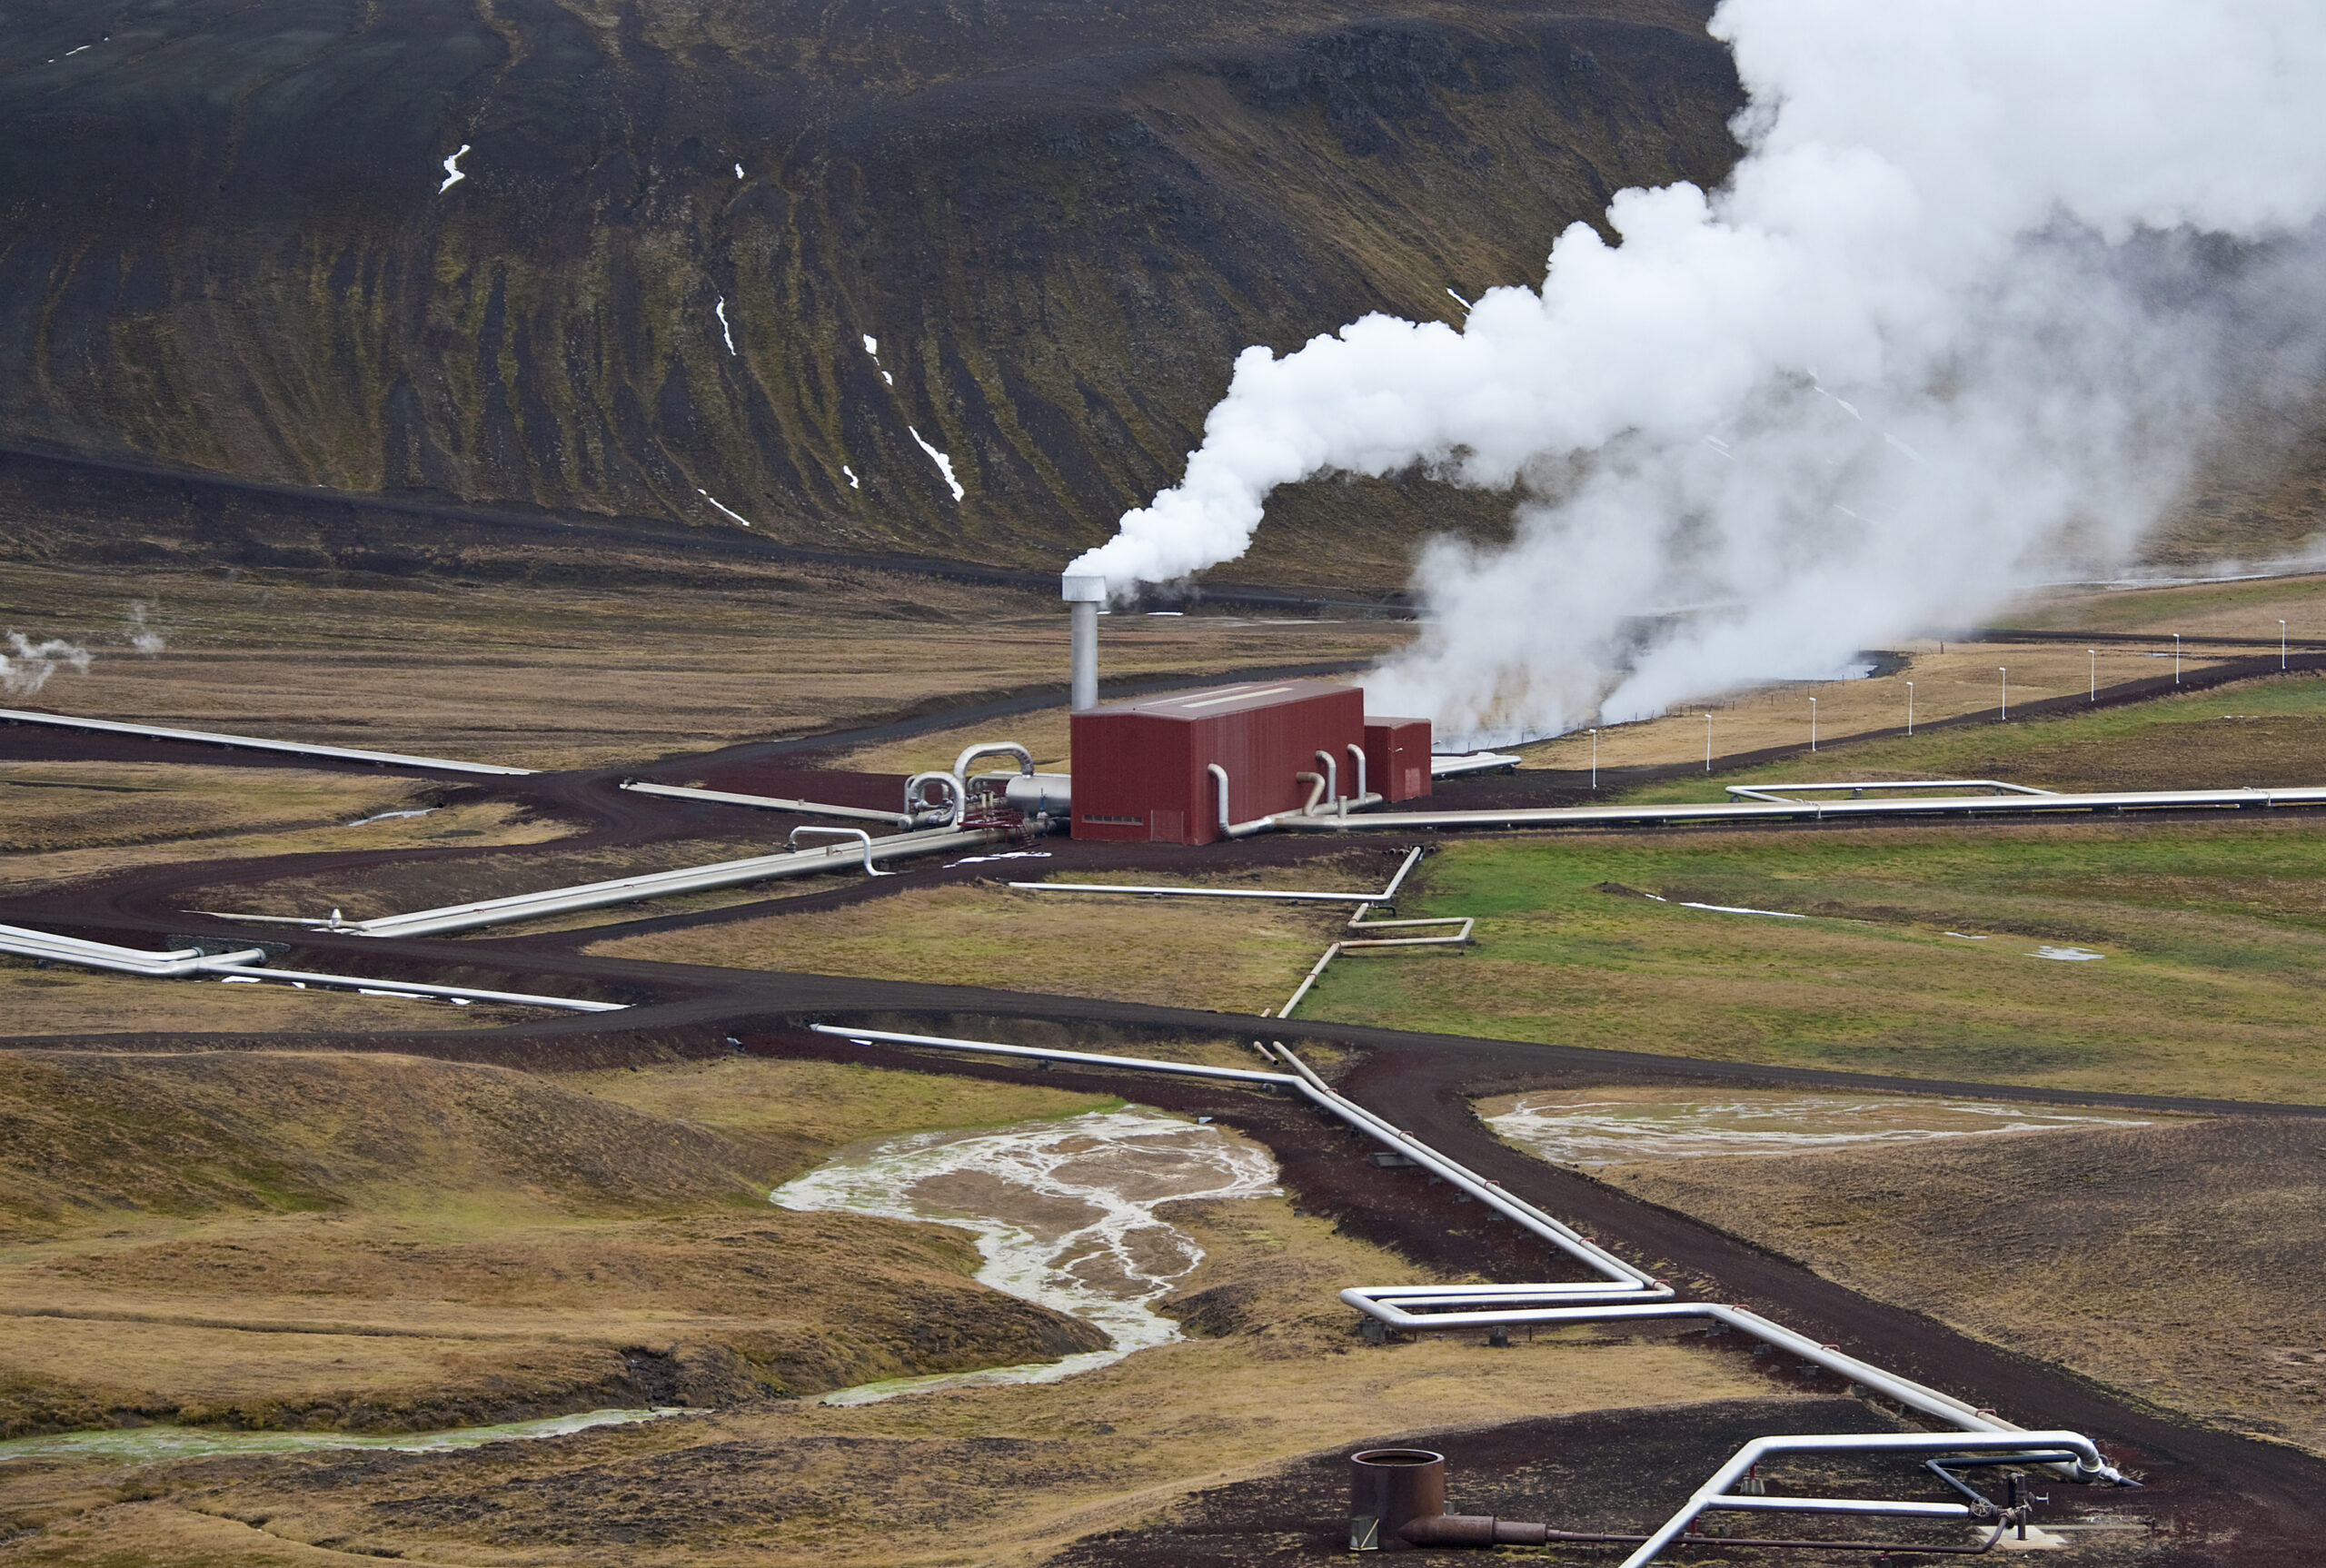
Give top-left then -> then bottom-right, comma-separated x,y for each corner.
1072,680 -> 1430,845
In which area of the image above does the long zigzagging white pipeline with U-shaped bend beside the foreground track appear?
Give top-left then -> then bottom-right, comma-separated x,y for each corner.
811,1024 -> 2126,1488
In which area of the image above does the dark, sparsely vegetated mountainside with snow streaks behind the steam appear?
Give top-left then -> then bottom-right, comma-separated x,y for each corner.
0,0 -> 1737,565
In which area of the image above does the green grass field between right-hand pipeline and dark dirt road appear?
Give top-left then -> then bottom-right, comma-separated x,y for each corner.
1303,817 -> 2326,1103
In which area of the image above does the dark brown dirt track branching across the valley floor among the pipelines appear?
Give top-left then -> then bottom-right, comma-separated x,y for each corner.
0,698 -> 2326,1563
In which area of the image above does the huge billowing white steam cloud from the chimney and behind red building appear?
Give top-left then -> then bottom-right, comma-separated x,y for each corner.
1070,0 -> 2326,738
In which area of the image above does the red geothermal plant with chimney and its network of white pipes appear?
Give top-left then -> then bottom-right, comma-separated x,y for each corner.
14,562 -> 2326,1568
